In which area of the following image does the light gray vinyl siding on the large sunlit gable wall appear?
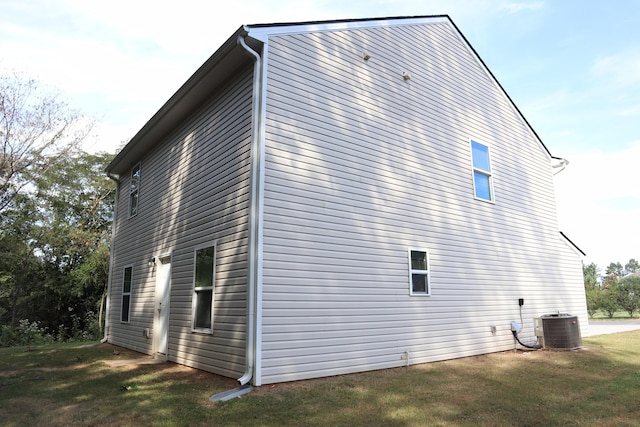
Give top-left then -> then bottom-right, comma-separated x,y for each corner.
261,23 -> 587,384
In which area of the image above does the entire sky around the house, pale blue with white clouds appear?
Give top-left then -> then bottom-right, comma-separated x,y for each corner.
0,0 -> 640,270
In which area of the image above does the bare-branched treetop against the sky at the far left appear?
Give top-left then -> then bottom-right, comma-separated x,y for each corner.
0,72 -> 91,212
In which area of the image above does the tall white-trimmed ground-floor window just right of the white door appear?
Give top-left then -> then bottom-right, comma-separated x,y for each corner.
192,244 -> 216,333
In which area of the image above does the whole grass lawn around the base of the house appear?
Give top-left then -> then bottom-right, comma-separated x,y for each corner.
0,331 -> 640,426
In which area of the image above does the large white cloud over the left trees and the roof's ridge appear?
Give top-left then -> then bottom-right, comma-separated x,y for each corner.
0,0 -> 510,149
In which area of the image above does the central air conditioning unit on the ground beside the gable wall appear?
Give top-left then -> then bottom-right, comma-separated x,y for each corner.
533,313 -> 582,348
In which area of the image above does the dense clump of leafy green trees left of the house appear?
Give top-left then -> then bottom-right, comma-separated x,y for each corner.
0,153 -> 115,337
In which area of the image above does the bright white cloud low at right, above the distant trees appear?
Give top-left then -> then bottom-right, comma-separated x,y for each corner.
556,141 -> 640,269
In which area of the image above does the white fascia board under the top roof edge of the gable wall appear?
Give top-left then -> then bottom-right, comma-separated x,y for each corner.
244,16 -> 451,43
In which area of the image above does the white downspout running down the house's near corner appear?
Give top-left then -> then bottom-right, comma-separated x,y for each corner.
238,35 -> 262,385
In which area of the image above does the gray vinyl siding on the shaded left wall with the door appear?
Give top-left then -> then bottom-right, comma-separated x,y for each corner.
109,67 -> 252,376
